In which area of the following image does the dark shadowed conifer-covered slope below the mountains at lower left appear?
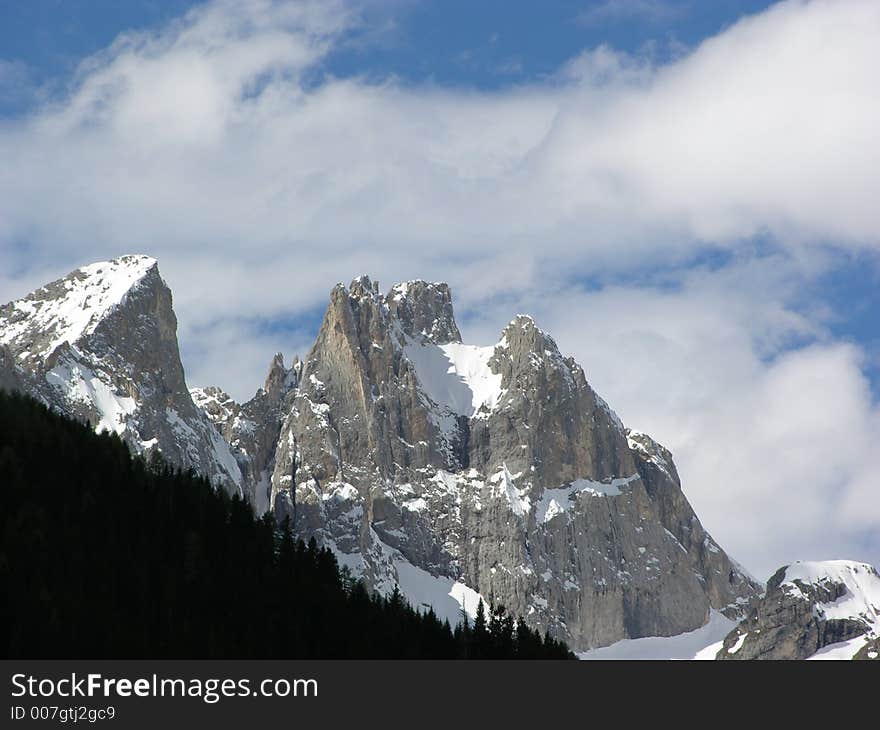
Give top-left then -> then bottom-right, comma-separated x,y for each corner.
0,392 -> 571,659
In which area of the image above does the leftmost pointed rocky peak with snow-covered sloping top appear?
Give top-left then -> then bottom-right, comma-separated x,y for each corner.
0,256 -> 242,492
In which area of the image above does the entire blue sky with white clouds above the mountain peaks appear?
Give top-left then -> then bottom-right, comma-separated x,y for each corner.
0,0 -> 880,578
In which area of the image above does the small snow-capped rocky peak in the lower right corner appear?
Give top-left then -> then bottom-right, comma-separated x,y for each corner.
716,560 -> 880,659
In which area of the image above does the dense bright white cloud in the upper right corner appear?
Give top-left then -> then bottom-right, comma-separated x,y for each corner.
555,2 -> 880,245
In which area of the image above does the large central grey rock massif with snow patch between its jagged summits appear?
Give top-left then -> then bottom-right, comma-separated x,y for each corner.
262,277 -> 756,650
